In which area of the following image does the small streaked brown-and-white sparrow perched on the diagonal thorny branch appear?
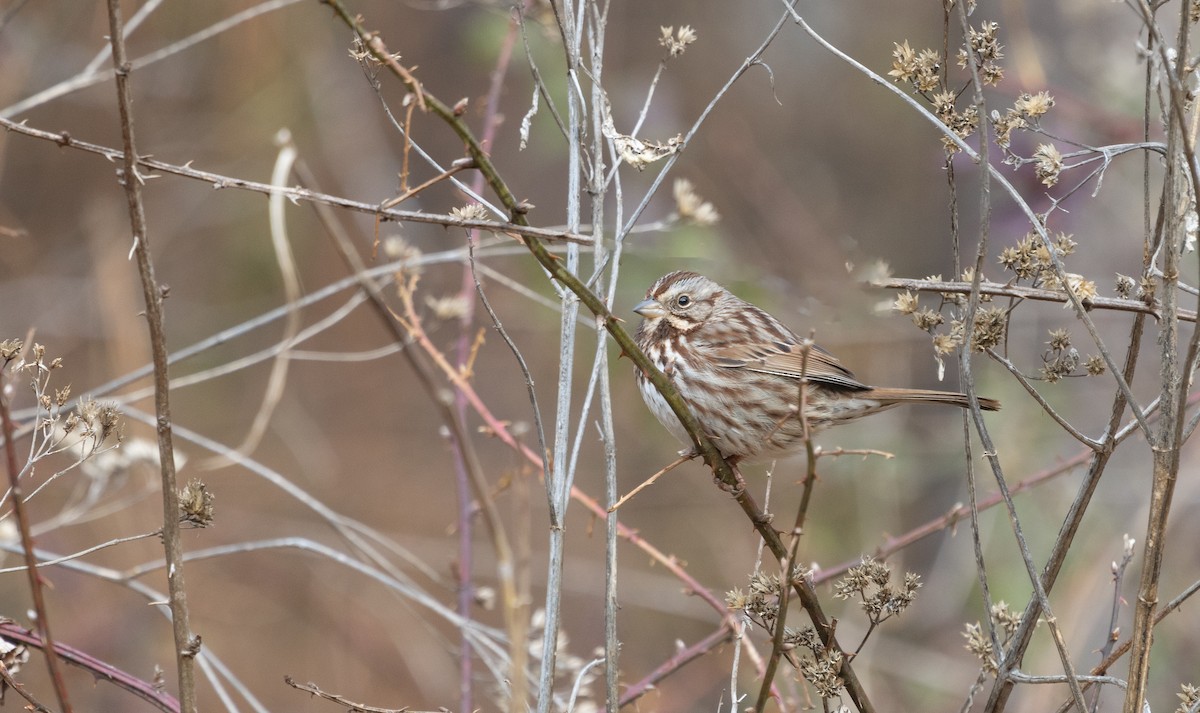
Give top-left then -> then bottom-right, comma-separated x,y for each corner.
634,271 -> 1000,463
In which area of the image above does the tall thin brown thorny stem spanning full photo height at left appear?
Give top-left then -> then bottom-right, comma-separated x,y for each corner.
108,0 -> 200,713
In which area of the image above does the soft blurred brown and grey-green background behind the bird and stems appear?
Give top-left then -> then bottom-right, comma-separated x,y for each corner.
0,0 -> 1200,712
